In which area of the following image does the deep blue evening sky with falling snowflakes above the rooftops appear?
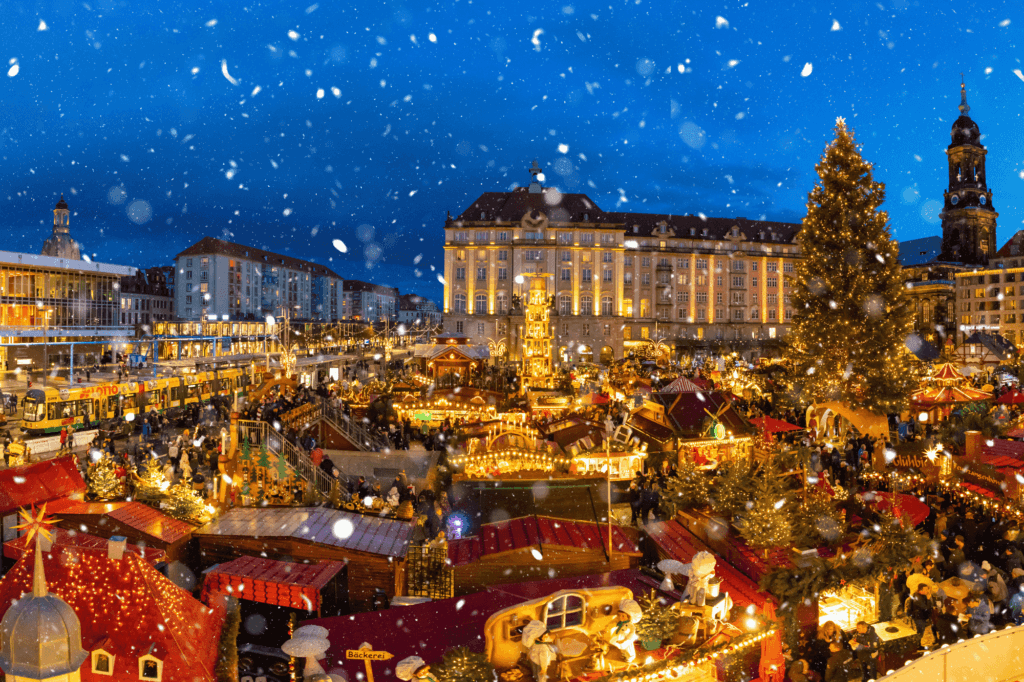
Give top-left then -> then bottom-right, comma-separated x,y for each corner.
0,0 -> 1024,297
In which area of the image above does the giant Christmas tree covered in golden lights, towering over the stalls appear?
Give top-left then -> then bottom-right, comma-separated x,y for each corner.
788,119 -> 915,414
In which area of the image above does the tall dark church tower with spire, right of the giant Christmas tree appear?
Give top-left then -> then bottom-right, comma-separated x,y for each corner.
939,81 -> 999,265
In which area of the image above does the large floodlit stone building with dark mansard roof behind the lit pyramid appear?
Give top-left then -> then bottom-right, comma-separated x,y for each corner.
443,163 -> 801,363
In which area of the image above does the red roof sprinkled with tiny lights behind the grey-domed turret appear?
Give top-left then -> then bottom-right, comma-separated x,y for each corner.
0,546 -> 224,682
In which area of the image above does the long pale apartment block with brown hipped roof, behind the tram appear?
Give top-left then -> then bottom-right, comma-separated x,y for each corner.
174,237 -> 342,322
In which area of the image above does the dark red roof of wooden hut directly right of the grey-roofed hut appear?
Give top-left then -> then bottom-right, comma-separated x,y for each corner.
449,516 -> 640,566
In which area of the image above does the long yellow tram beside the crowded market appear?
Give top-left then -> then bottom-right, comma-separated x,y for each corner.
22,370 -> 252,435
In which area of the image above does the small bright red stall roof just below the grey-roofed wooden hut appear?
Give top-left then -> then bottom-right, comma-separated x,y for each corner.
203,556 -> 345,611
